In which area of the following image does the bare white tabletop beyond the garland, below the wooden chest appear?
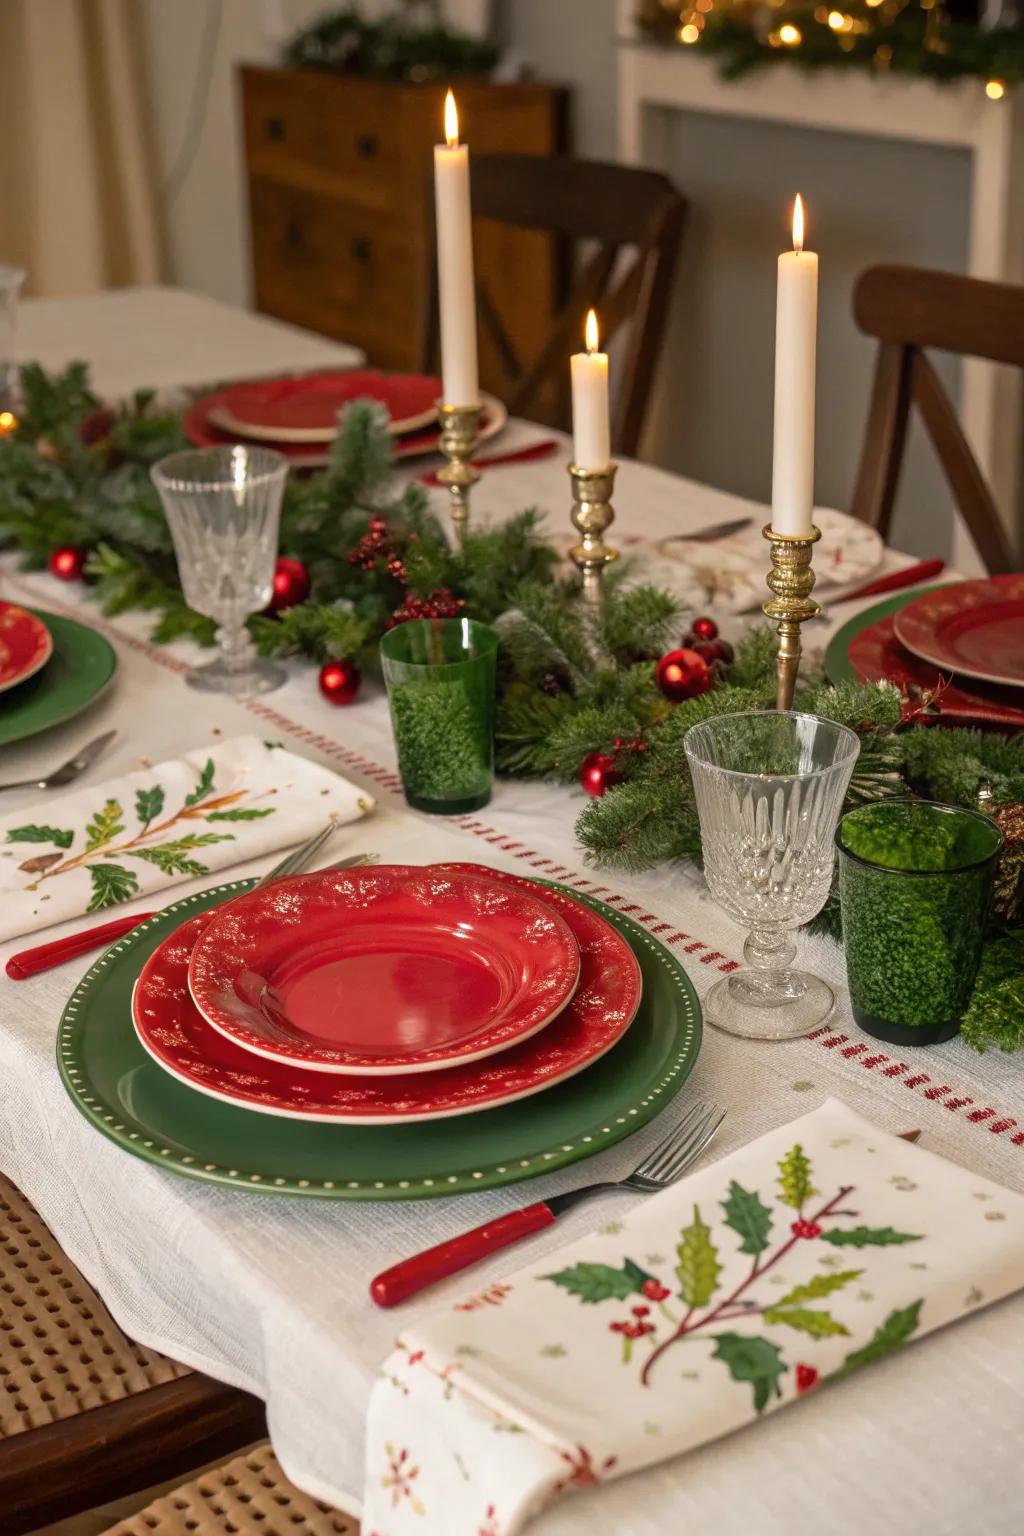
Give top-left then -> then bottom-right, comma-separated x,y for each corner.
14,287 -> 364,399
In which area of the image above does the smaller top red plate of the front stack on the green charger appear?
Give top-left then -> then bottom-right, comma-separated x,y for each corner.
189,865 -> 580,1077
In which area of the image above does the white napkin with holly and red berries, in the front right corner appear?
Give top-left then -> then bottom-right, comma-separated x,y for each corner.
362,1100 -> 1024,1536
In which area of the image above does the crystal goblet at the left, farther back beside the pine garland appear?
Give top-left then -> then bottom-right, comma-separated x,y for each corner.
150,447 -> 289,694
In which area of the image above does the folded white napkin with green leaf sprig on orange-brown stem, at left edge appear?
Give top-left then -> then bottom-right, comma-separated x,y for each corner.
0,736 -> 373,943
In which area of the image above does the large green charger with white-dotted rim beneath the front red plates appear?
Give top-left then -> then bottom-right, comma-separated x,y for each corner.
57,880 -> 700,1200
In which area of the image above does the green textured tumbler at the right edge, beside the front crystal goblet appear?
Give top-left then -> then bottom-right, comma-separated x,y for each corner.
835,800 -> 1003,1046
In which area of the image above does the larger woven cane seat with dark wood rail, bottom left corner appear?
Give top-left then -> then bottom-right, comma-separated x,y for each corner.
0,1177 -> 266,1536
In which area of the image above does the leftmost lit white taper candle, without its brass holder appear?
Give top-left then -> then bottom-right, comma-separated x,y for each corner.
434,91 -> 479,406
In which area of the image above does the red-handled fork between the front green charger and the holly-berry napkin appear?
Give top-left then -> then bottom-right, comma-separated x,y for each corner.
370,1104 -> 725,1307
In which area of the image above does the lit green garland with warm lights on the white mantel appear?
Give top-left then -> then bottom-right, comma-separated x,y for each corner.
636,0 -> 1024,91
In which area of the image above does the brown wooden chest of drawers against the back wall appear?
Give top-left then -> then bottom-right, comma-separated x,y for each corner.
241,68 -> 567,389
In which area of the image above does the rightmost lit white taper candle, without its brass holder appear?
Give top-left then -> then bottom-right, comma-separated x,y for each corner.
772,197 -> 818,538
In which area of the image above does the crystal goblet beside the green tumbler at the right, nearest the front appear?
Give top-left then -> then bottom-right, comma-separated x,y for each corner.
685,710 -> 860,1040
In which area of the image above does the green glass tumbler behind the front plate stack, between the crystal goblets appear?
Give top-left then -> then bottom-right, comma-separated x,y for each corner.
381,619 -> 499,816
